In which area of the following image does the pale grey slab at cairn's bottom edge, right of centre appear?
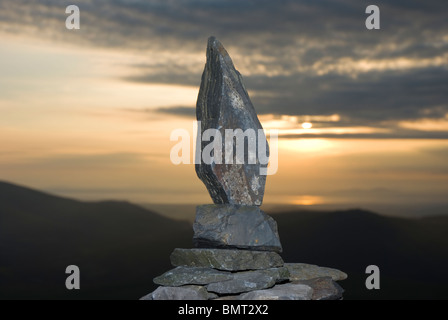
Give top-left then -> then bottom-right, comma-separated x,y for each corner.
239,283 -> 313,300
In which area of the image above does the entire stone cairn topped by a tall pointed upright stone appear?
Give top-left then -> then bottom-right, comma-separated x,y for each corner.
142,37 -> 347,300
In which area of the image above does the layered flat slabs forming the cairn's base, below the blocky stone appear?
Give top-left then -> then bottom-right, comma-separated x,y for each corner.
141,249 -> 347,300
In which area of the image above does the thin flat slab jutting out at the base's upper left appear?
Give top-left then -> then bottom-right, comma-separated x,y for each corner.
154,267 -> 233,287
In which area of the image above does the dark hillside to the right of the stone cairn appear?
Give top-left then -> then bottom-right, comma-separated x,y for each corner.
274,209 -> 448,299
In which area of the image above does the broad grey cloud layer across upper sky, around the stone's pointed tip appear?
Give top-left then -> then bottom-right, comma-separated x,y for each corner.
0,0 -> 448,137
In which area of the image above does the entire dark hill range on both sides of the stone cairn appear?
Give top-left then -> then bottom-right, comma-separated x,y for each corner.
0,182 -> 448,299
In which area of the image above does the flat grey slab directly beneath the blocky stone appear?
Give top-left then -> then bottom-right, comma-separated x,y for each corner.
170,248 -> 283,271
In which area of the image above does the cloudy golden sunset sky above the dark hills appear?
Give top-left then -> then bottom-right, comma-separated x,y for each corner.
0,0 -> 448,215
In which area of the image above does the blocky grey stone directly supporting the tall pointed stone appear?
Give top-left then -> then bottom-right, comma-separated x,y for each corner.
193,204 -> 282,252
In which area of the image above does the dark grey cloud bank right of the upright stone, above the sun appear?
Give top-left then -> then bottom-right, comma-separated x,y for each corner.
246,68 -> 448,123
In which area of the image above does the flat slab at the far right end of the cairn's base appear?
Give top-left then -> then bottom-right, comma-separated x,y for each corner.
285,263 -> 347,281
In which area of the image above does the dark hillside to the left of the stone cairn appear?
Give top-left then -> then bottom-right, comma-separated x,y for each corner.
0,182 -> 193,299
